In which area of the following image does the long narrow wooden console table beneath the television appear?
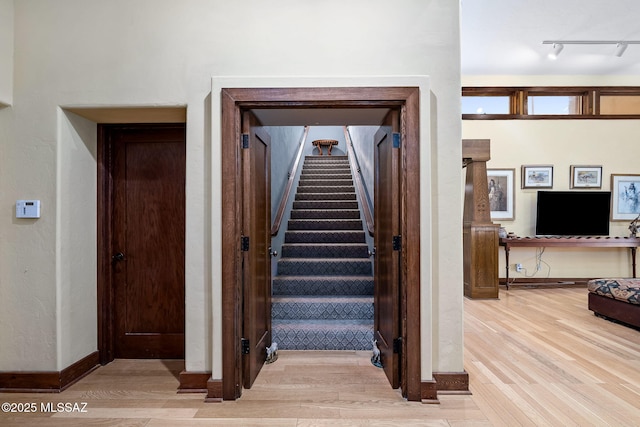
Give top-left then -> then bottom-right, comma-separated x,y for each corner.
499,236 -> 640,289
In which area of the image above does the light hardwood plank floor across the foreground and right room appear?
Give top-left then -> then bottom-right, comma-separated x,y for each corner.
0,288 -> 640,427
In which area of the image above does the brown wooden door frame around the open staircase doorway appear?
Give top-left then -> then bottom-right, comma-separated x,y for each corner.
220,87 -> 429,401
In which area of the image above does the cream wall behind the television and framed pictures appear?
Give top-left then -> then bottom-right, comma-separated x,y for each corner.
462,76 -> 640,278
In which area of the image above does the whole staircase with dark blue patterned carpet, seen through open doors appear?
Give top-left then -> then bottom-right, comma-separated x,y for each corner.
272,156 -> 373,350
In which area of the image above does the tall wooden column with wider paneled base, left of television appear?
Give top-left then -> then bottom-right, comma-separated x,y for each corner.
462,139 -> 500,298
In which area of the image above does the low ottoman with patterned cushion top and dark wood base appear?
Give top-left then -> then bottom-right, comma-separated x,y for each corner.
587,278 -> 640,328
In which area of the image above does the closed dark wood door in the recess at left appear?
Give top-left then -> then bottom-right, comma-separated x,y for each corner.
107,124 -> 185,358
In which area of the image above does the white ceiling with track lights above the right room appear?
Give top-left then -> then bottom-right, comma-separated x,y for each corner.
460,0 -> 640,76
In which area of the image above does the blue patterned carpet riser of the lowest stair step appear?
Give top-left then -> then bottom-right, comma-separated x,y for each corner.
271,320 -> 373,350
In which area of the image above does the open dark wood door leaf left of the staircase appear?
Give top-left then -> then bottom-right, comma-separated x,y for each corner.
242,112 -> 271,388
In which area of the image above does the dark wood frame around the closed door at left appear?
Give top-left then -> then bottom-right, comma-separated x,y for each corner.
96,123 -> 186,365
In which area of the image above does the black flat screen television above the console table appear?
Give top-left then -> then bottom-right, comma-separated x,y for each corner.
536,191 -> 611,236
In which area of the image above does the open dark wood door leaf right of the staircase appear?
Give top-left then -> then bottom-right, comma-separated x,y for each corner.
374,112 -> 402,388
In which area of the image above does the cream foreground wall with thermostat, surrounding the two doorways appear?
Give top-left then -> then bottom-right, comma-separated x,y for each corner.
0,0 -> 463,378
